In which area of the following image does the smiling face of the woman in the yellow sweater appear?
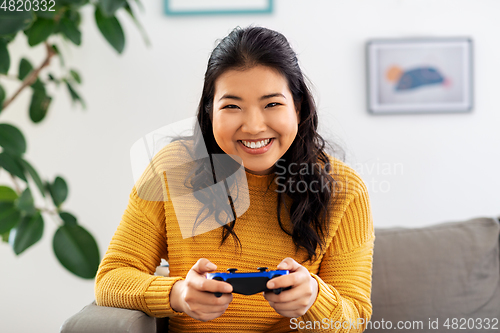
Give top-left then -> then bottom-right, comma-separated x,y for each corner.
212,65 -> 300,174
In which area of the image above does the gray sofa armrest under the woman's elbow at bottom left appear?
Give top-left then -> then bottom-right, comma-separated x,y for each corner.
61,302 -> 163,333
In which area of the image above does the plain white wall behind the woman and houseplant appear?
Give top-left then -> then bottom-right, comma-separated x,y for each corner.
0,0 -> 500,333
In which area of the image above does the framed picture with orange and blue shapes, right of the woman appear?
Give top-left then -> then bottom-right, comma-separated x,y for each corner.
366,38 -> 473,114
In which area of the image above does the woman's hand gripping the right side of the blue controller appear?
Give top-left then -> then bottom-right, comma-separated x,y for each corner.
264,258 -> 318,318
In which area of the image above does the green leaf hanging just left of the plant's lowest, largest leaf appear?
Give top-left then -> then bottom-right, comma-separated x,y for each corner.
12,213 -> 43,255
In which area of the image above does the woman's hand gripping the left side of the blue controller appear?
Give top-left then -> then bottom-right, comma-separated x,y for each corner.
170,258 -> 233,321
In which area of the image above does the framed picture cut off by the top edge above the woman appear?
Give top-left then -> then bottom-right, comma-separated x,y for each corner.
164,0 -> 273,16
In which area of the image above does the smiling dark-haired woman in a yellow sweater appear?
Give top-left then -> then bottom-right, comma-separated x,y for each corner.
96,27 -> 374,333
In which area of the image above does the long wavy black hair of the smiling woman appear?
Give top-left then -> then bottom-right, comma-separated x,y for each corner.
177,26 -> 344,260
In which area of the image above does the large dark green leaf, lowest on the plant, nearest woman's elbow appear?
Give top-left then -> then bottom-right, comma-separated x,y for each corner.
52,225 -> 100,279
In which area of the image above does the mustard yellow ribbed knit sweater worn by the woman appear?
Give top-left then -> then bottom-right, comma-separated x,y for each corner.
95,144 -> 374,333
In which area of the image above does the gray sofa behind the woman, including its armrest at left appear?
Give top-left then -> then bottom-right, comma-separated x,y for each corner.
61,218 -> 500,333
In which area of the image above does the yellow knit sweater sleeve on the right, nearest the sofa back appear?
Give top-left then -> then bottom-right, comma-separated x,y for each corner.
297,170 -> 375,332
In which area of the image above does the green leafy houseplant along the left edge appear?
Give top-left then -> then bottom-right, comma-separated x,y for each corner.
0,0 -> 149,279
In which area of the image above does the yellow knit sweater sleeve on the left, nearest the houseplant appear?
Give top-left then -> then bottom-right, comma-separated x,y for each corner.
95,187 -> 182,317
